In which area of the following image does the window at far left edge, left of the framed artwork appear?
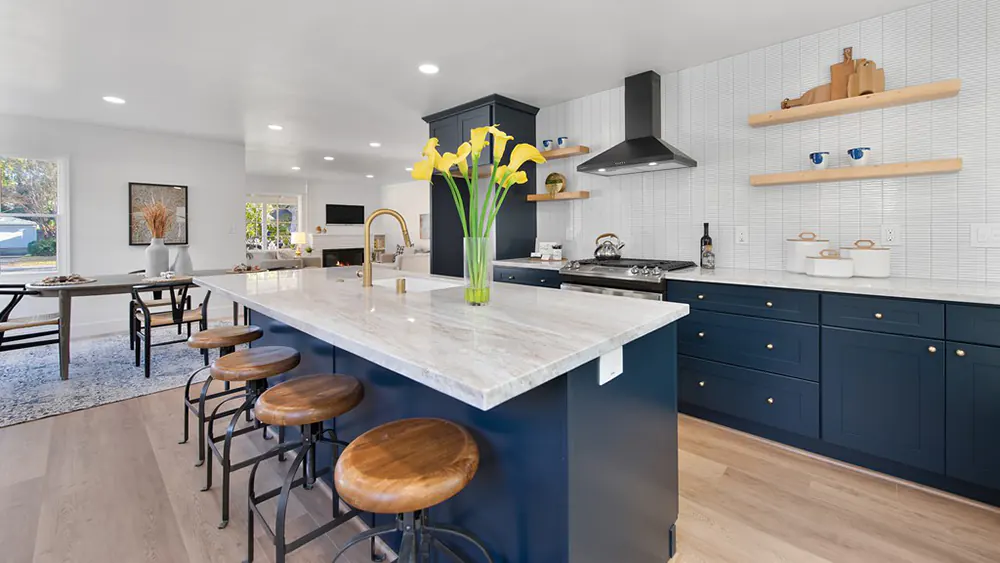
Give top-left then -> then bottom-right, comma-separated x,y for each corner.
0,156 -> 61,274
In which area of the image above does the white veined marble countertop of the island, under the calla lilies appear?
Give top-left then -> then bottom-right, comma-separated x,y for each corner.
195,268 -> 688,410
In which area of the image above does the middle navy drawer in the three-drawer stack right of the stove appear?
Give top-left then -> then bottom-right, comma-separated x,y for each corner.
677,311 -> 819,381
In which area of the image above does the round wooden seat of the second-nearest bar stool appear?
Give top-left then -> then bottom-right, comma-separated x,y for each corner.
254,374 -> 365,426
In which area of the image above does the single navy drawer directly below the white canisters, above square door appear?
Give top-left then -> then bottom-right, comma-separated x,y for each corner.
823,294 -> 944,339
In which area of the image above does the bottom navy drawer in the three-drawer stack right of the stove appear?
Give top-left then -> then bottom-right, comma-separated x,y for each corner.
677,356 -> 819,438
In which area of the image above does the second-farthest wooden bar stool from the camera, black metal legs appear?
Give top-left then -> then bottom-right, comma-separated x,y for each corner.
202,346 -> 301,528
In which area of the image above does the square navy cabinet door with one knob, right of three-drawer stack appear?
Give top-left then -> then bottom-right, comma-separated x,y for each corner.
820,327 -> 945,473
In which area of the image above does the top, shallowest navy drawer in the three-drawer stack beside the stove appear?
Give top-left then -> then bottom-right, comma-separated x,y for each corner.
667,281 -> 819,323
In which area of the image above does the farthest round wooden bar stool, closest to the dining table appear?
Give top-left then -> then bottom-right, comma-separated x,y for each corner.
180,326 -> 264,467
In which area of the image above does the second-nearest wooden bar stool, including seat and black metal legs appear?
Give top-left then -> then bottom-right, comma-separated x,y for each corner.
247,375 -> 365,563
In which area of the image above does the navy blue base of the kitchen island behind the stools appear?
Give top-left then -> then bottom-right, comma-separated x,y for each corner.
251,311 -> 678,563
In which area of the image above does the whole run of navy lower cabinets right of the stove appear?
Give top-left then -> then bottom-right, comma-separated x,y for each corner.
667,281 -> 1000,506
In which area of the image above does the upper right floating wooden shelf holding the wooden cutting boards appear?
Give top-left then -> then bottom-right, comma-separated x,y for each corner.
749,78 -> 962,127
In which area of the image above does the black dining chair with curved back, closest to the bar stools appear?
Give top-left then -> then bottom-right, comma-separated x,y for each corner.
132,281 -> 212,378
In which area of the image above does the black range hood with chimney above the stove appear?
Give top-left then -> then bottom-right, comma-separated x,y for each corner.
576,70 -> 698,176
